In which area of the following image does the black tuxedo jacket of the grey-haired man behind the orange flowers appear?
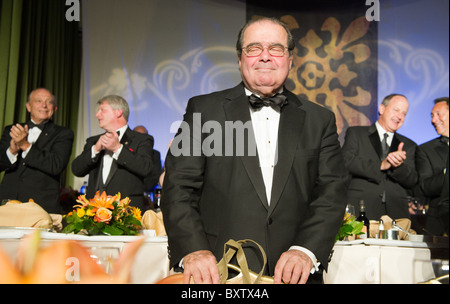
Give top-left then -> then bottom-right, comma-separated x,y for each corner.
72,128 -> 154,210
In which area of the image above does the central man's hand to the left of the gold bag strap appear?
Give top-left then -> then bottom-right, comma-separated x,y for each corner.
183,250 -> 220,284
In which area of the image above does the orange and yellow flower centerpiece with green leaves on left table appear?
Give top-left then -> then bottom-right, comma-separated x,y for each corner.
63,191 -> 142,235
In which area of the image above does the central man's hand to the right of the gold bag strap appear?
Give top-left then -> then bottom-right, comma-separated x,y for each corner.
274,249 -> 313,284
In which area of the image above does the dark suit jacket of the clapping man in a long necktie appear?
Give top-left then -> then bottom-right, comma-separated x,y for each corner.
342,124 -> 417,220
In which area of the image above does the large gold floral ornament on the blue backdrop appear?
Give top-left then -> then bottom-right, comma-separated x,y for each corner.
281,16 -> 372,133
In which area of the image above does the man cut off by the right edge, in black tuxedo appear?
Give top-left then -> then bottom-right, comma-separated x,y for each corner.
416,97 -> 449,235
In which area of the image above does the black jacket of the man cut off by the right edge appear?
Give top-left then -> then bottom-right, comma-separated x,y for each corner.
416,137 -> 449,235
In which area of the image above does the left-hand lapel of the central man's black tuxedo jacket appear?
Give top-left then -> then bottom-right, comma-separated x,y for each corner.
224,84 -> 269,209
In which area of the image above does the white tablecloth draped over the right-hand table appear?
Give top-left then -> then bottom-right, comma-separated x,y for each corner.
324,239 -> 431,284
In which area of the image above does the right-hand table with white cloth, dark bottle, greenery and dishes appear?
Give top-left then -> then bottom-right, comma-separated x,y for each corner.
324,208 -> 449,284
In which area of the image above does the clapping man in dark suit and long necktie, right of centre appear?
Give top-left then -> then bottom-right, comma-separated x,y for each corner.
342,94 -> 417,220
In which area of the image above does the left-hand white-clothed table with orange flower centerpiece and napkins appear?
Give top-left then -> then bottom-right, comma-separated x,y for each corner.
0,192 -> 170,284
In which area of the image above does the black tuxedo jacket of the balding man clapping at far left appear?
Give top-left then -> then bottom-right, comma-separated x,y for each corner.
0,121 -> 74,213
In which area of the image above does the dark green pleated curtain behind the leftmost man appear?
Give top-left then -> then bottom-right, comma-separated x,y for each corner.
0,0 -> 81,186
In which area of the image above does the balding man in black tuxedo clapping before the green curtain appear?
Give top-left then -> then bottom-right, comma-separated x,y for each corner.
0,88 -> 74,213
